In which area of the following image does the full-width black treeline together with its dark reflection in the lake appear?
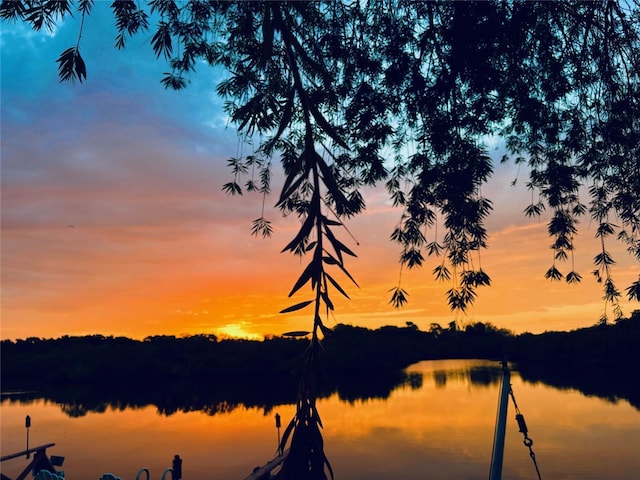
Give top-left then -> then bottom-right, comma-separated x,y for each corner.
1,311 -> 640,415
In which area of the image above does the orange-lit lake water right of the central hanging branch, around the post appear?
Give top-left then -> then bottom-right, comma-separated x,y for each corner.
321,360 -> 640,479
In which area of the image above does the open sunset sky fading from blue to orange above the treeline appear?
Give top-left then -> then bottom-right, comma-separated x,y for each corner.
0,2 -> 640,339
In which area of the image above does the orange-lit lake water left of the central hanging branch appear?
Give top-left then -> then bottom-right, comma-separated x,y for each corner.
1,401 -> 293,479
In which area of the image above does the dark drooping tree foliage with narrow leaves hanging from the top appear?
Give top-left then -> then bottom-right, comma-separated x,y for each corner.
0,0 -> 640,476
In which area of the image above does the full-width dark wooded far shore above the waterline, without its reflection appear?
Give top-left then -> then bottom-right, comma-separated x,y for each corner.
0,316 -> 640,384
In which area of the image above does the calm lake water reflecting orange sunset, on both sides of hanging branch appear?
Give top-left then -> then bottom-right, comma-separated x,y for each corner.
0,360 -> 640,480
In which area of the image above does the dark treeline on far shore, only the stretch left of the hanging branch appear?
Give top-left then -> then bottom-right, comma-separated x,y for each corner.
2,335 -> 305,383
